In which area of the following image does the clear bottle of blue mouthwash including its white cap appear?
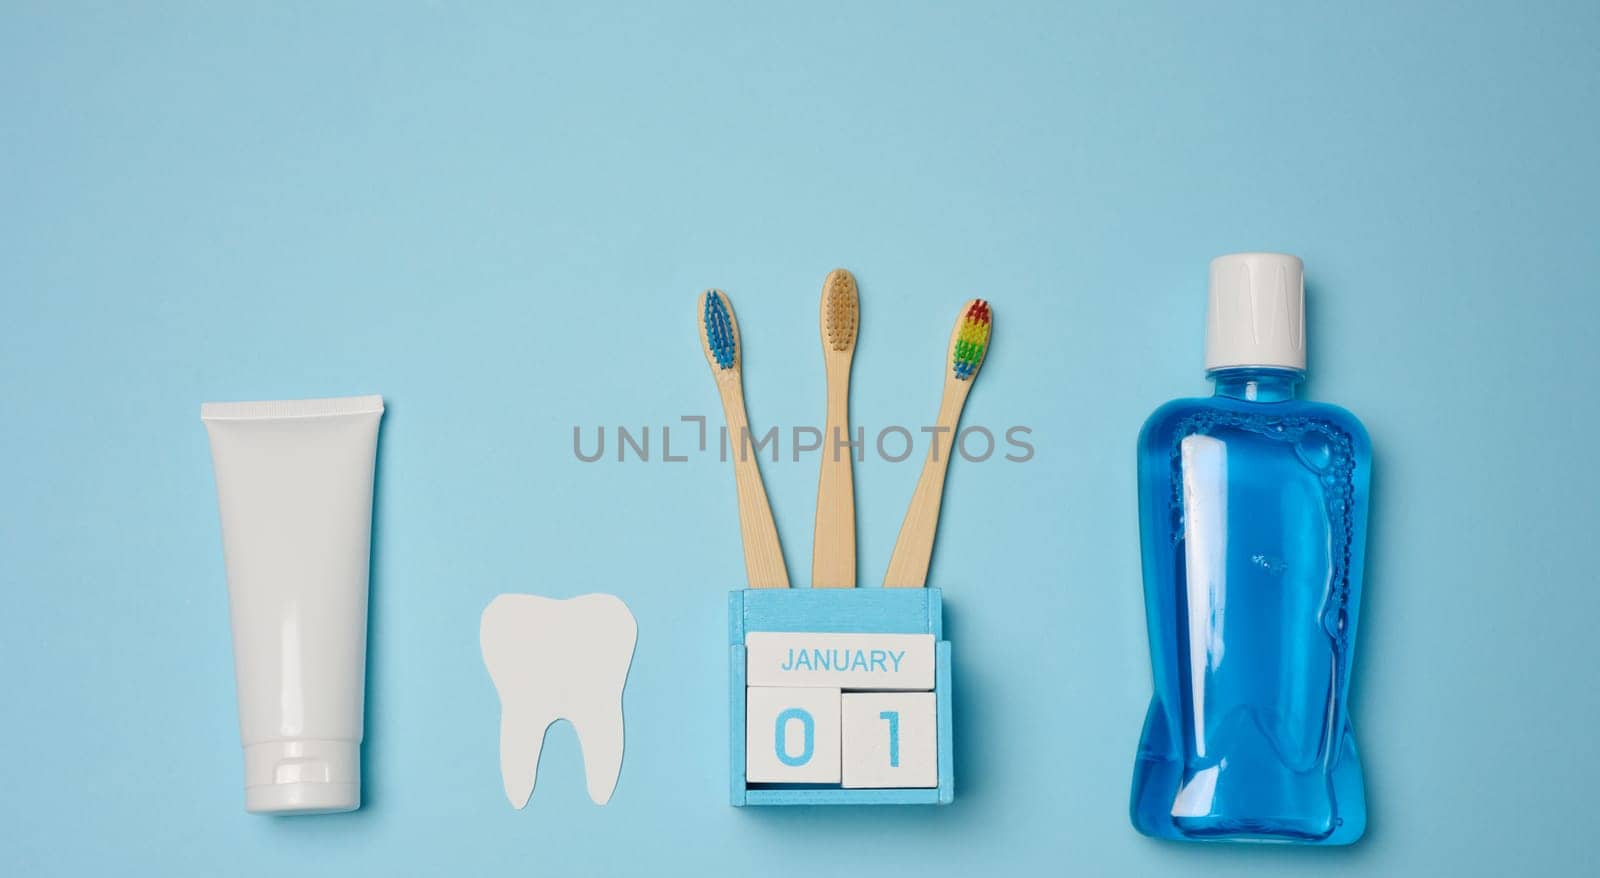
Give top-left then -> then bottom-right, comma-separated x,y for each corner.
1131,253 -> 1371,844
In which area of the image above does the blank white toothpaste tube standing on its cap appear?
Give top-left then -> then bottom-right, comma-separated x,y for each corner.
200,397 -> 384,814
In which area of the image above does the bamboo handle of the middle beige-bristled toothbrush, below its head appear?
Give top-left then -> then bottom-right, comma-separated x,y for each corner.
811,357 -> 856,589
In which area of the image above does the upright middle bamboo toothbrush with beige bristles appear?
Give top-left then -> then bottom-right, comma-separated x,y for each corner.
811,269 -> 861,589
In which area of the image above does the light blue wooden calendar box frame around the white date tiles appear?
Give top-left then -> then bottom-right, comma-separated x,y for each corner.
728,589 -> 955,806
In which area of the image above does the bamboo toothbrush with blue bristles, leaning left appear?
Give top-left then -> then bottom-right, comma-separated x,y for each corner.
699,289 -> 789,589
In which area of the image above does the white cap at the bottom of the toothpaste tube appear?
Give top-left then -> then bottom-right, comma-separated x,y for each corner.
245,740 -> 362,814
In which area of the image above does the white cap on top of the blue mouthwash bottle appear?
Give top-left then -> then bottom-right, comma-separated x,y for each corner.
1205,253 -> 1306,371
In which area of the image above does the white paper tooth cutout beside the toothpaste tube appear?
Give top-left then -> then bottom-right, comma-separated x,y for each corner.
478,595 -> 638,808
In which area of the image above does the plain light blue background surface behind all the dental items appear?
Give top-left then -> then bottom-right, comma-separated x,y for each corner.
0,2 -> 1600,875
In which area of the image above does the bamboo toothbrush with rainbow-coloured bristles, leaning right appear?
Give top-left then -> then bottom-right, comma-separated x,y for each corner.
883,299 -> 992,589
